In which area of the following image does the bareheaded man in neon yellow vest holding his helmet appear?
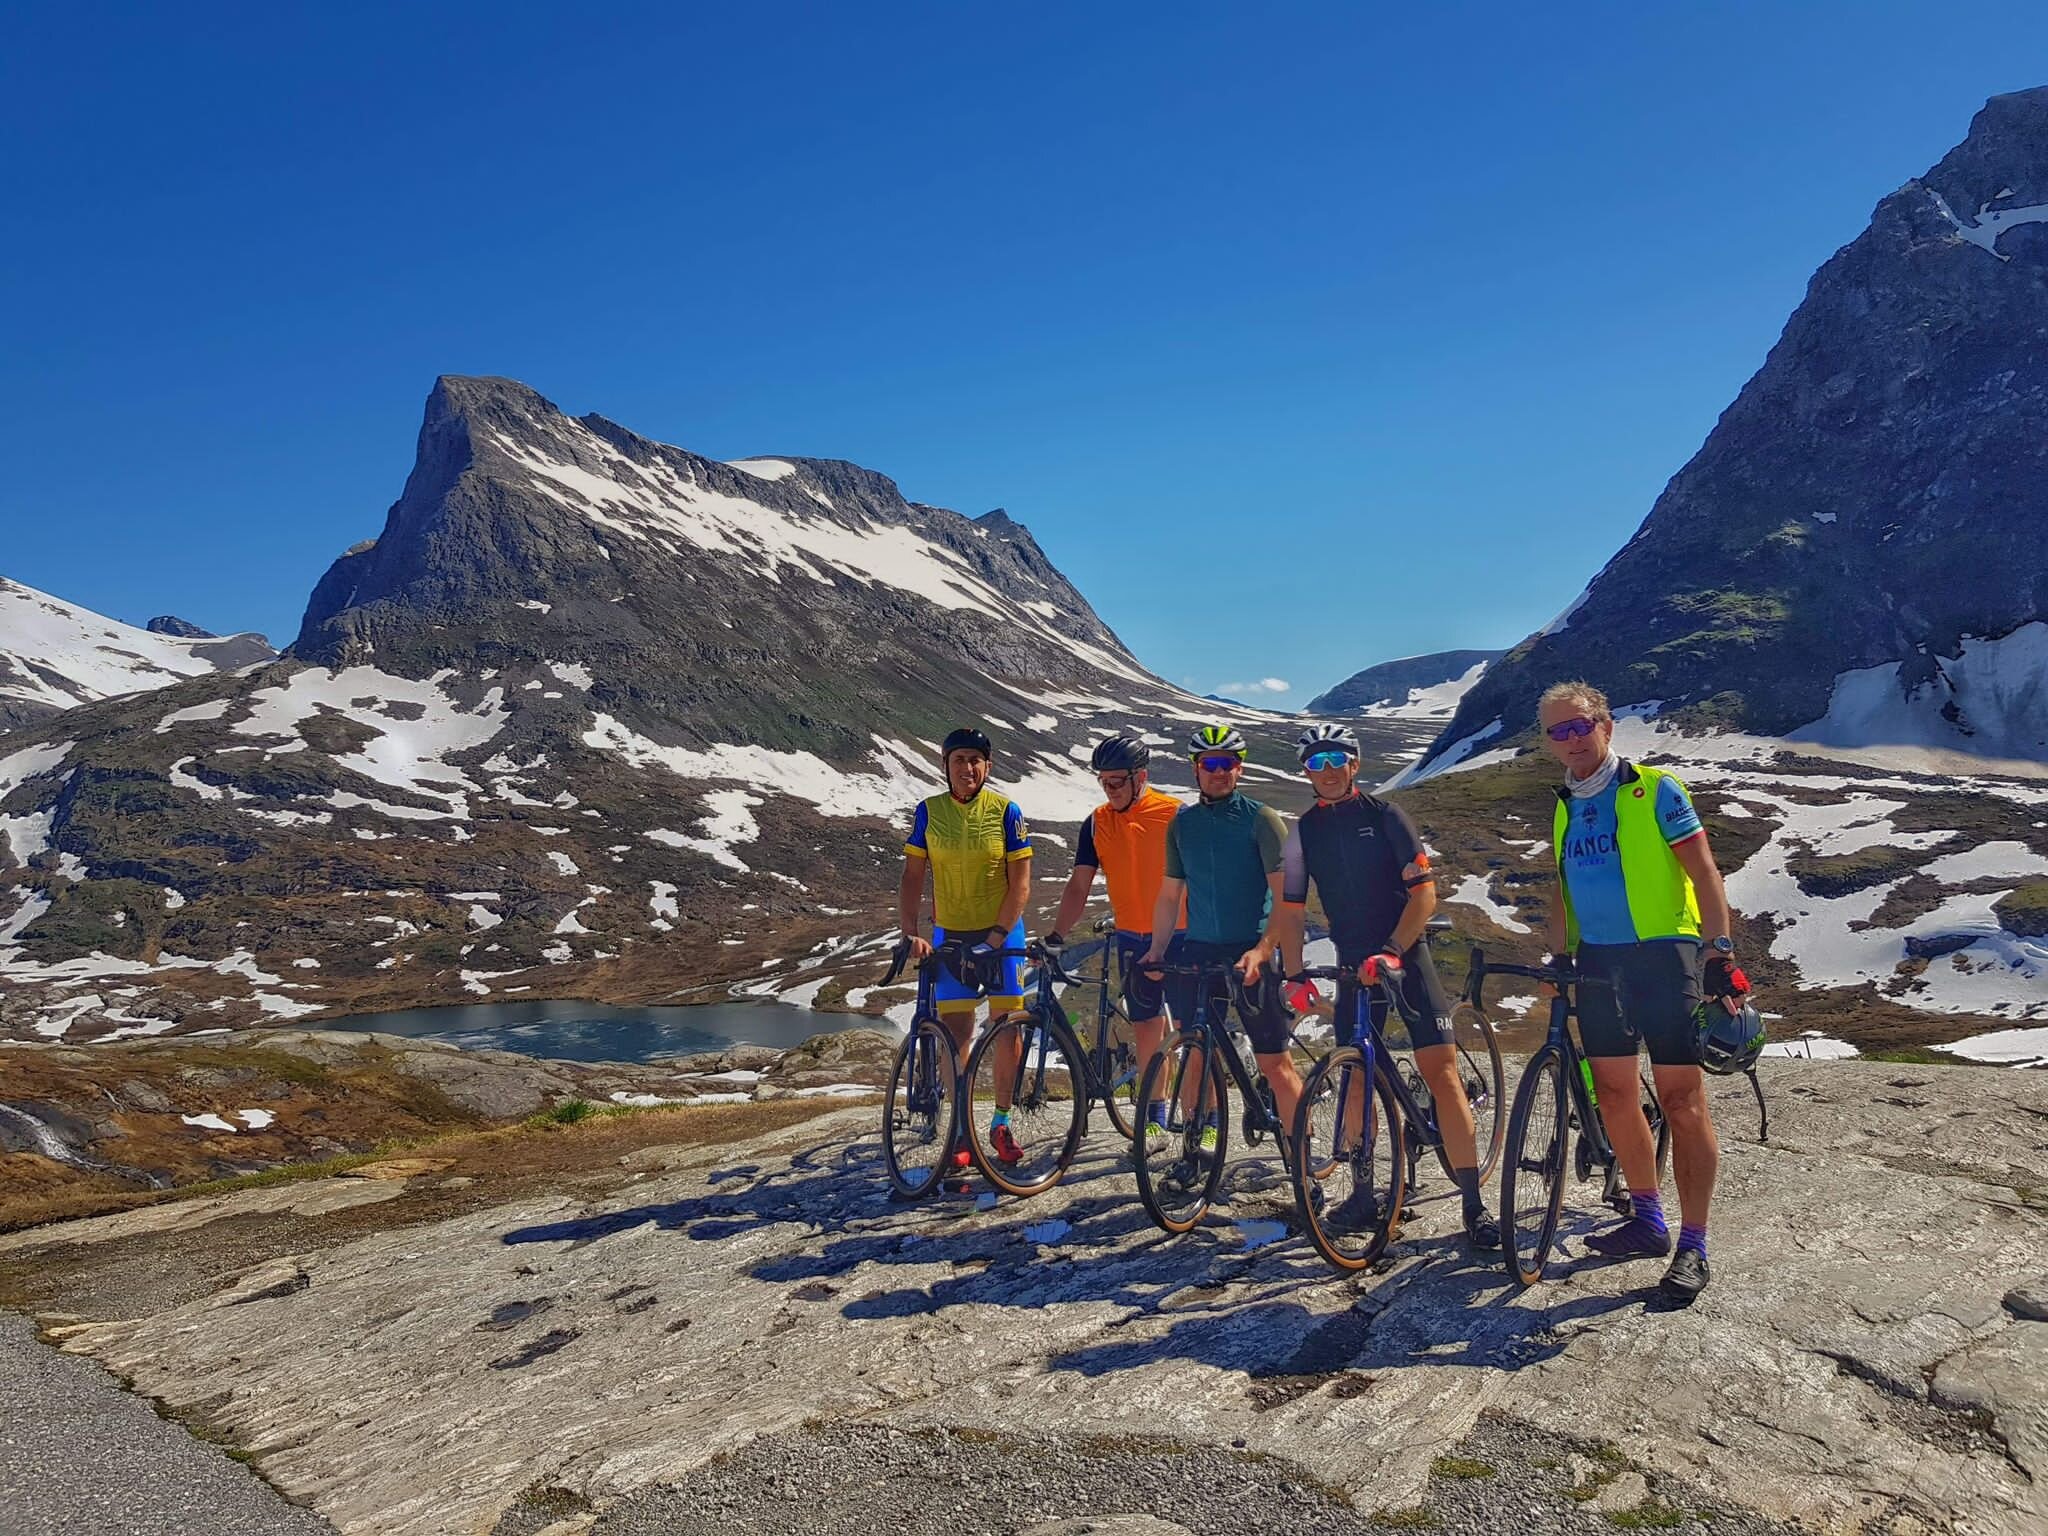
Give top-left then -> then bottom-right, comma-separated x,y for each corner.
1536,682 -> 1749,1300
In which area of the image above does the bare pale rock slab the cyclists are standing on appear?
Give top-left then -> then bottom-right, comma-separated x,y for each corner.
6,1061 -> 2048,1536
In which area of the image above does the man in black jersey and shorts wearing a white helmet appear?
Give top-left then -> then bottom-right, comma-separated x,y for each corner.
1274,725 -> 1501,1249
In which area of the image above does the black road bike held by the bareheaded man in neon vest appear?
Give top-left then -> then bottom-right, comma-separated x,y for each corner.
1464,946 -> 1671,1286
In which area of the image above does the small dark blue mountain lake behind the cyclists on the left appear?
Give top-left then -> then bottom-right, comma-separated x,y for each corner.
328,999 -> 887,1061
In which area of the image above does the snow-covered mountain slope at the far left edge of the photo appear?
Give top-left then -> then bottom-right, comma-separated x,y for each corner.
0,575 -> 272,727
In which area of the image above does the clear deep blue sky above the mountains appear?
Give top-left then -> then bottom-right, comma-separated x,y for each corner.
0,0 -> 2048,702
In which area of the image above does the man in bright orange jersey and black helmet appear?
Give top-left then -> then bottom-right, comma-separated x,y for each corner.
1044,735 -> 1192,1147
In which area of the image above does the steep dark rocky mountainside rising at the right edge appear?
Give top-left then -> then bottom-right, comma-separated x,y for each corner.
1432,88 -> 2048,760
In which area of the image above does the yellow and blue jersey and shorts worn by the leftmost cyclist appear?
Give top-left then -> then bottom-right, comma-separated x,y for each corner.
903,788 -> 1030,1014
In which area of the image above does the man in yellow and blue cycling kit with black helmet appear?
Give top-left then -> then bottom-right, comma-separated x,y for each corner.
897,727 -> 1030,1165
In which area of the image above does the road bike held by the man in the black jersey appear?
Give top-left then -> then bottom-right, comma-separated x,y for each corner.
1288,967 -> 1505,1274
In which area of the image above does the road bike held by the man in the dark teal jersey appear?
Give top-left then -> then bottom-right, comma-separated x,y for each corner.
1130,961 -> 1294,1233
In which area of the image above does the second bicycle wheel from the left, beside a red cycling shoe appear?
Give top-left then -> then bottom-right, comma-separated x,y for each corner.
961,1012 -> 1087,1196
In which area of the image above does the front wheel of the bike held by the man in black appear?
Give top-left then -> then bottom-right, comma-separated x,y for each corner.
1288,1044 -> 1407,1274
